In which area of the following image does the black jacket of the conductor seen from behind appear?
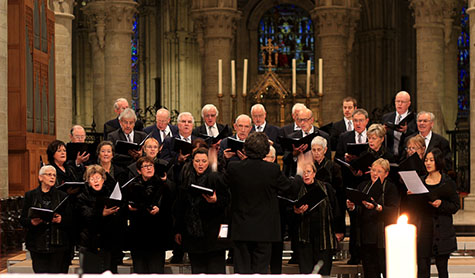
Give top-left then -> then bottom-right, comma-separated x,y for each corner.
224,158 -> 290,242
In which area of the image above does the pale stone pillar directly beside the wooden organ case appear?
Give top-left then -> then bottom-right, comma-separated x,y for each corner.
50,0 -> 74,142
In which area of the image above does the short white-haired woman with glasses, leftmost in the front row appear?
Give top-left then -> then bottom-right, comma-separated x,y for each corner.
20,165 -> 71,273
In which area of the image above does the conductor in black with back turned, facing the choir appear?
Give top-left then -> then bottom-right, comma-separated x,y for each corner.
224,132 -> 290,274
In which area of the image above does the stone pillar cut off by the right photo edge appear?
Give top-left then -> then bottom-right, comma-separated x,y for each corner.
464,0 -> 475,211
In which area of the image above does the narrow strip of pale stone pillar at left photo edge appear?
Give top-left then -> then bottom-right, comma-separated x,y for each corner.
0,1 -> 8,198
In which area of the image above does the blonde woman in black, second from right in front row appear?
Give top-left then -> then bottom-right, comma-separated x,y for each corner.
346,158 -> 399,278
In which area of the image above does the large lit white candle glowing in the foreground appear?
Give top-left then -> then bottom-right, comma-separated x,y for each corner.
386,215 -> 417,278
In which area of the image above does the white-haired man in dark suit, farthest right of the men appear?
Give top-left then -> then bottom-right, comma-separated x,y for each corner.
404,111 -> 453,170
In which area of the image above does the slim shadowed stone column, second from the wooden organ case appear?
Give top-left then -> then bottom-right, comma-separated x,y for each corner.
84,2 -> 107,131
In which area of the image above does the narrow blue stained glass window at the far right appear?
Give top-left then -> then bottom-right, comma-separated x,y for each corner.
457,6 -> 470,119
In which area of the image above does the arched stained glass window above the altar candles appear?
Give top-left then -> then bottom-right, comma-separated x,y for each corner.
258,4 -> 315,72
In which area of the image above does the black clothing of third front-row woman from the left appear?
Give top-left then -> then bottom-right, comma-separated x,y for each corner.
127,176 -> 173,274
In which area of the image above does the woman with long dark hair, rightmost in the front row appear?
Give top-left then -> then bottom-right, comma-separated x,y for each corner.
408,148 -> 460,278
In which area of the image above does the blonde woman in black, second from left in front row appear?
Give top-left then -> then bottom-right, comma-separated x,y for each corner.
77,165 -> 125,273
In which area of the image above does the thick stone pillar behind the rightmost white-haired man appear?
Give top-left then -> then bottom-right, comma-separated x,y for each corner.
410,0 -> 448,134
